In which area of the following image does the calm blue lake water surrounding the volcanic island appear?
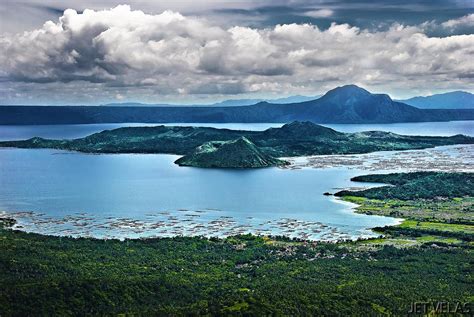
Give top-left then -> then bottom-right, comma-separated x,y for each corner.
0,122 -> 474,240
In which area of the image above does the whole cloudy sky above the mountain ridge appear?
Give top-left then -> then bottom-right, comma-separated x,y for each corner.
0,0 -> 474,105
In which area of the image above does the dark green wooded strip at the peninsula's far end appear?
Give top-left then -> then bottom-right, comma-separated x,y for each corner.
336,172 -> 474,200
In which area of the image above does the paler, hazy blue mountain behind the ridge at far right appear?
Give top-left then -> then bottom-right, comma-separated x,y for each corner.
399,91 -> 474,109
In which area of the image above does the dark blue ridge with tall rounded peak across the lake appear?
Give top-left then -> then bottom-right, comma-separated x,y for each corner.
0,85 -> 474,124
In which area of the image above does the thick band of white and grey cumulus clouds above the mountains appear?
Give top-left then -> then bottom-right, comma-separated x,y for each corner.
0,5 -> 474,100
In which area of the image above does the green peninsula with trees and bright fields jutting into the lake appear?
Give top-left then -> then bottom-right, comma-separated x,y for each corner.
337,172 -> 474,246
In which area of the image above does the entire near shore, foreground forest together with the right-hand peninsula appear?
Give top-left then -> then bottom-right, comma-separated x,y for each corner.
0,172 -> 474,316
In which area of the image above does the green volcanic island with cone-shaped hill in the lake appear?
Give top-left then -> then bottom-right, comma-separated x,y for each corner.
0,121 -> 474,168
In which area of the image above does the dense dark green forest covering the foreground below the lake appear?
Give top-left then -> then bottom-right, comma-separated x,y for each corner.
0,229 -> 474,316
